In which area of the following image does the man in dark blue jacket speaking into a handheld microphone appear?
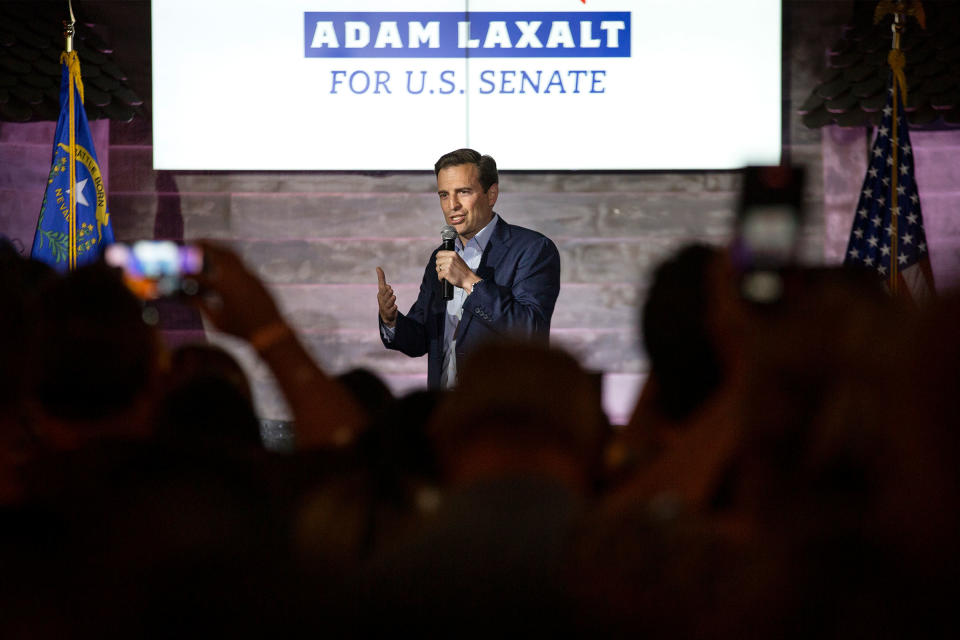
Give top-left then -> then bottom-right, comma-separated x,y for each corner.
377,149 -> 560,389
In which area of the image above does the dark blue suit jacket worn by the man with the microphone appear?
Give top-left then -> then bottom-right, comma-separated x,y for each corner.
383,217 -> 560,389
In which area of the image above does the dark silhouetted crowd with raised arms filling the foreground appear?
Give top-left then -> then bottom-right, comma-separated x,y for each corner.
0,238 -> 960,638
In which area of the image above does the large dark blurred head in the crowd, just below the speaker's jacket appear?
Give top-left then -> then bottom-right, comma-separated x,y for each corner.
431,341 -> 609,487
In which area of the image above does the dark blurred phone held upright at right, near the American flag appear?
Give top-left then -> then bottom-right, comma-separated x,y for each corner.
731,165 -> 805,304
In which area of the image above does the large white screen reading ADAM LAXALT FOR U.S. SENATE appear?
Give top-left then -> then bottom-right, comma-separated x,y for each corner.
152,0 -> 781,170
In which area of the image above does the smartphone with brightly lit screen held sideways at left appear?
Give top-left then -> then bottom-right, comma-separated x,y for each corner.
104,240 -> 203,300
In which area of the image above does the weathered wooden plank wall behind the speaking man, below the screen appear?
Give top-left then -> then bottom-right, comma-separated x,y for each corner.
111,161 -> 756,417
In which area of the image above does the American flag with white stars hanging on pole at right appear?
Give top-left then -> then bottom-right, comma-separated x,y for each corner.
843,74 -> 934,305
